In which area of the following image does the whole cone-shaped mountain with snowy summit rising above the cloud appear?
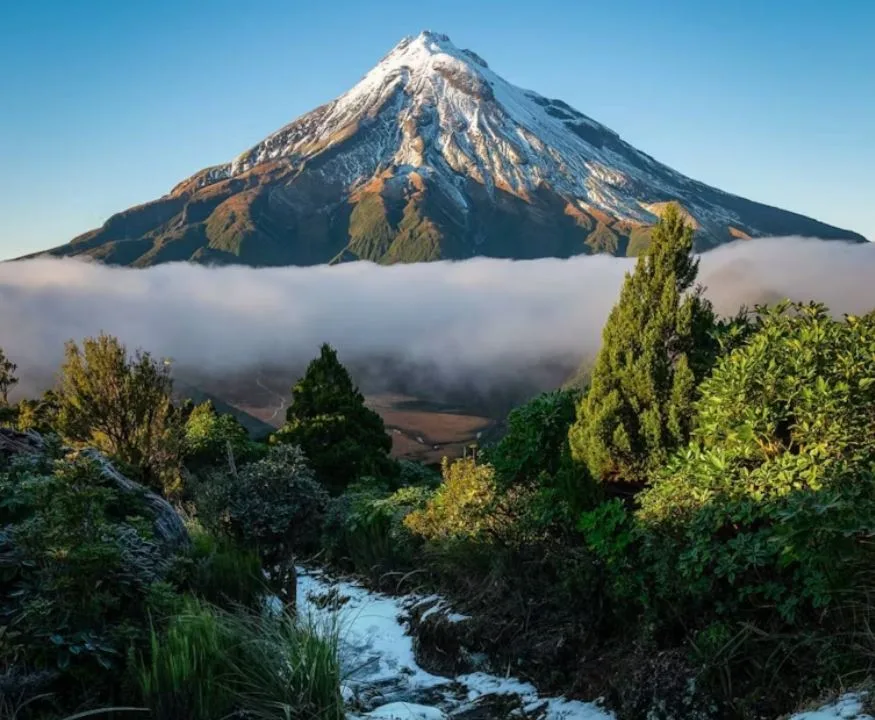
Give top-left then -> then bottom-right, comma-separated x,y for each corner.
29,32 -> 864,267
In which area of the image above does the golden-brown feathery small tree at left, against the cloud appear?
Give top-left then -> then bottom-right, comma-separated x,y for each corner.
56,333 -> 181,490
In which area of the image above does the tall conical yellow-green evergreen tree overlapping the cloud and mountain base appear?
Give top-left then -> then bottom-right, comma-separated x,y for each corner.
569,204 -> 717,484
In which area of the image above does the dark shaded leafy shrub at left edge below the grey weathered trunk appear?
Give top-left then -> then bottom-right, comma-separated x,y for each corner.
0,460 -> 169,699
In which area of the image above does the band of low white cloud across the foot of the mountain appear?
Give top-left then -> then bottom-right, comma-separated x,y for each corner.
0,238 -> 875,402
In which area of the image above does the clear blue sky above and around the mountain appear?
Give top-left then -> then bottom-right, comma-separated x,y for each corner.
0,0 -> 875,258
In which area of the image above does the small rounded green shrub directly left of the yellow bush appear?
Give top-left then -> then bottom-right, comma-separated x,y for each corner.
323,480 -> 432,577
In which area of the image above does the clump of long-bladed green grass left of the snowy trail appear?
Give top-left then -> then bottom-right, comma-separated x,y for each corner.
137,601 -> 343,720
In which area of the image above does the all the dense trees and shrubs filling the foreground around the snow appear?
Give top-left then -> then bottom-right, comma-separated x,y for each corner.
0,205 -> 875,720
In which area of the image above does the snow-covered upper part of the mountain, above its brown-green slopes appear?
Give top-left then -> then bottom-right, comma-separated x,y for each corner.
201,31 -> 752,233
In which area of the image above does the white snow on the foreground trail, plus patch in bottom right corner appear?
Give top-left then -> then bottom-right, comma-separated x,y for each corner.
298,568 -> 875,720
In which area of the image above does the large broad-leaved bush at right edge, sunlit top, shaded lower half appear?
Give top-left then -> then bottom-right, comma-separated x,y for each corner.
581,305 -> 875,713
